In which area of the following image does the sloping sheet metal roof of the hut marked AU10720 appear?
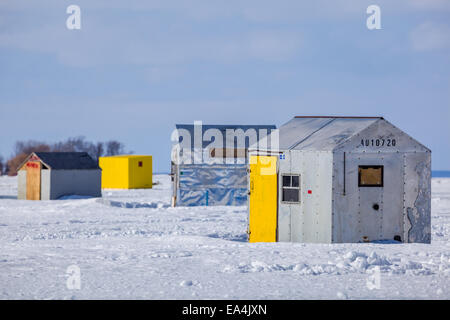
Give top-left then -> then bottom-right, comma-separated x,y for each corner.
279,116 -> 383,151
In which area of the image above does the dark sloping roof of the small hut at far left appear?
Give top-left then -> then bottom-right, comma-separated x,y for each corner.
34,152 -> 100,170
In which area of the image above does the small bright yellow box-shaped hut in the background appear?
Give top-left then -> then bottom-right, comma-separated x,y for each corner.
99,155 -> 153,189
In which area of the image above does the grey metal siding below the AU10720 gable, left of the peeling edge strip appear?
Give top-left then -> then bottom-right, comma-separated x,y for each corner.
333,153 -> 410,242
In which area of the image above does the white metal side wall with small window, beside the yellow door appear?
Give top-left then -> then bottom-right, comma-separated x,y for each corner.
278,150 -> 333,243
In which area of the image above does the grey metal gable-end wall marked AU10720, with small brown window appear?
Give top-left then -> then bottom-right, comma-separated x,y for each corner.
333,119 -> 431,242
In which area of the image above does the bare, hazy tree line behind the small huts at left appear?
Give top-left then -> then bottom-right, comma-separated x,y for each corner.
0,136 -> 133,176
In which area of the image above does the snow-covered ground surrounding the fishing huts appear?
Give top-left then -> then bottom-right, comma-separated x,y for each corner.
0,175 -> 450,299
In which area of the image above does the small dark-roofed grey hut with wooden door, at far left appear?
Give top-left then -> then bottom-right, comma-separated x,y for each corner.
17,152 -> 102,200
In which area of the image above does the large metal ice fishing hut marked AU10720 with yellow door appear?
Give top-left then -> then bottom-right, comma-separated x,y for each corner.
249,117 -> 431,243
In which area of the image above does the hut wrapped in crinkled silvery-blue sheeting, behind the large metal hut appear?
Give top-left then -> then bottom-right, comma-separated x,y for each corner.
171,122 -> 276,206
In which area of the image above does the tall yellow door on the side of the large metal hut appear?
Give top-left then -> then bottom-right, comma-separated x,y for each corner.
249,156 -> 278,242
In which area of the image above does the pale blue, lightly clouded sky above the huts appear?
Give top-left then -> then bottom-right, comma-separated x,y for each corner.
0,0 -> 450,171
